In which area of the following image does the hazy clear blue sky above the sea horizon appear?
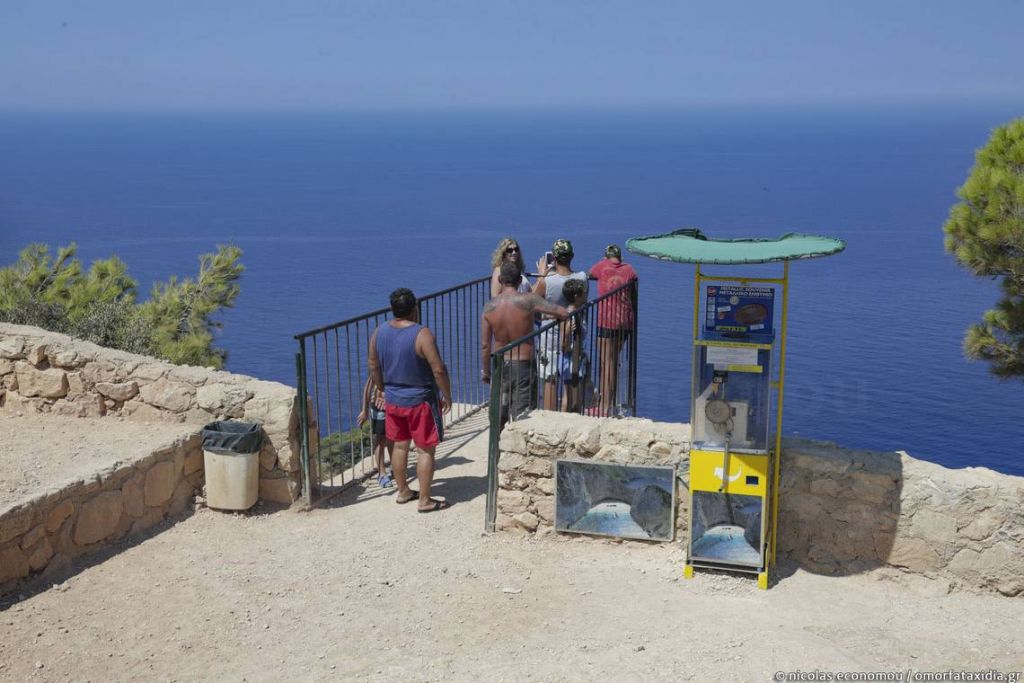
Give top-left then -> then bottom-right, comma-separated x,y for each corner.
0,0 -> 1024,110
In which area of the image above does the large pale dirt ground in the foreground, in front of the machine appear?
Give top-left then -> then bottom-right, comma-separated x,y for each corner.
0,411 -> 1024,681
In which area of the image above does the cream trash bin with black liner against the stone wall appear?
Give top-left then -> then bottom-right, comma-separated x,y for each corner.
203,421 -> 263,510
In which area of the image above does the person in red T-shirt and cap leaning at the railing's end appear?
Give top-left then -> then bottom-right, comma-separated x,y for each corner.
590,245 -> 637,415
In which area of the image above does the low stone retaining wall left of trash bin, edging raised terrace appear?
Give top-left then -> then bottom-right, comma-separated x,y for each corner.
0,434 -> 203,595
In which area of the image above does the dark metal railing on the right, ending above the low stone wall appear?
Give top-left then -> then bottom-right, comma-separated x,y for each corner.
484,281 -> 639,531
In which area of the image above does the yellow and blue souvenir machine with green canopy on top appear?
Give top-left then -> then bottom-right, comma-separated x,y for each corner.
627,229 -> 846,588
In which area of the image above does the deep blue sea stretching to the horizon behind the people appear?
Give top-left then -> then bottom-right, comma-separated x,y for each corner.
0,104 -> 1024,474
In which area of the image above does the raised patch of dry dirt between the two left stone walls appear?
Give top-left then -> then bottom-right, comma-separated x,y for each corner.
0,415 -> 196,510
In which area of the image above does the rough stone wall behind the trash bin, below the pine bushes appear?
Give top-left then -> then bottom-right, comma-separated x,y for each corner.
0,324 -> 300,504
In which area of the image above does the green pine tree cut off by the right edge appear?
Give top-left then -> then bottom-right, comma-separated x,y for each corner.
944,119 -> 1024,379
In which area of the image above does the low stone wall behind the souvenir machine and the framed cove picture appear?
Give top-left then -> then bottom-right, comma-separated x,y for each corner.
497,411 -> 1024,596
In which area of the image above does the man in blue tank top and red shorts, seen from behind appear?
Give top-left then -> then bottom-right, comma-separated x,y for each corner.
369,288 -> 452,512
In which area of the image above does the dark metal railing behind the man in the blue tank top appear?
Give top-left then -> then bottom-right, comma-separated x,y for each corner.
295,278 -> 490,504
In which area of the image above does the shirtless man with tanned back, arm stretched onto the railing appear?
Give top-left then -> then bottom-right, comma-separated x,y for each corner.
480,261 -> 568,425
